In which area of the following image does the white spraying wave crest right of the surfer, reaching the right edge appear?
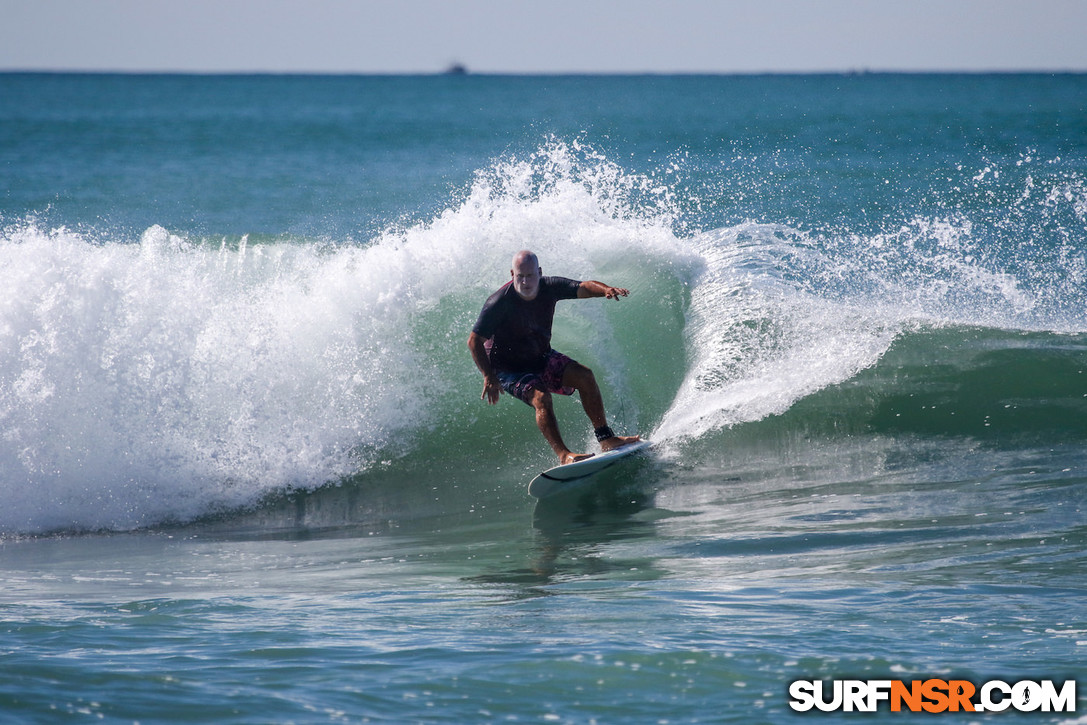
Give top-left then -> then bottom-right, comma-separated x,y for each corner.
653,206 -> 1087,441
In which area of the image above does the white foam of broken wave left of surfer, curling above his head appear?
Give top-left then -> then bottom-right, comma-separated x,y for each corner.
0,143 -> 679,533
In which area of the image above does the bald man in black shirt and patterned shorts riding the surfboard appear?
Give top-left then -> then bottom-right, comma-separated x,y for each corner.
468,250 -> 639,464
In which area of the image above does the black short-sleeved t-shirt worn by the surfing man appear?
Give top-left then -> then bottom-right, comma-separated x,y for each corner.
472,277 -> 582,373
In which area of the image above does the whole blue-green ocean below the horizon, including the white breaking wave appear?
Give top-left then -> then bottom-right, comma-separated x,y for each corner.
0,74 -> 1087,723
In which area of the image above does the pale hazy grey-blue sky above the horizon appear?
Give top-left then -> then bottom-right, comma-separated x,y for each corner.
0,0 -> 1087,73
